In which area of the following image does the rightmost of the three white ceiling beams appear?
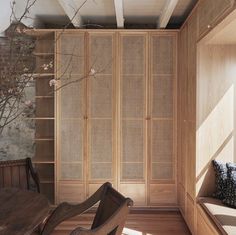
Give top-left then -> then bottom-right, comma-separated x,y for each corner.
157,0 -> 179,28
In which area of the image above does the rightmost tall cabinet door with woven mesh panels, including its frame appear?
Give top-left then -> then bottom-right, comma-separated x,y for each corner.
148,34 -> 177,205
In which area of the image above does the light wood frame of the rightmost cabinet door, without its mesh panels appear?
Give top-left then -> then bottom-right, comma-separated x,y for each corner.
148,32 -> 178,206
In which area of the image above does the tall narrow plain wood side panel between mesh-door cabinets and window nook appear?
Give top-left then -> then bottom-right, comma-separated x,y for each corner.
177,9 -> 197,233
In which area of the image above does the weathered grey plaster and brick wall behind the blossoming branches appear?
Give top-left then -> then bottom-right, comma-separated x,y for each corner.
0,37 -> 35,160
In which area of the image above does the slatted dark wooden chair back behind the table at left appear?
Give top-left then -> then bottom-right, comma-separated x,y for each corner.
0,158 -> 40,193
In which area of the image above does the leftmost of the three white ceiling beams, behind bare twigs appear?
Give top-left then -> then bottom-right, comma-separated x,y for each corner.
58,0 -> 83,28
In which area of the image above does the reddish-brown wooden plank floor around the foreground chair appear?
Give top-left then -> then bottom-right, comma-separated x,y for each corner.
53,211 -> 190,235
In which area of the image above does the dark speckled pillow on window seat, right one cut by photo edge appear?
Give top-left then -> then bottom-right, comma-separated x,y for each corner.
223,163 -> 236,208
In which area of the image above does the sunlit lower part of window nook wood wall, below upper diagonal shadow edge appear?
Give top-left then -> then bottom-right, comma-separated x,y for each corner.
196,85 -> 234,196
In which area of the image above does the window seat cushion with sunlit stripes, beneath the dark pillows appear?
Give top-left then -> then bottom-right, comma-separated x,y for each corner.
198,197 -> 236,235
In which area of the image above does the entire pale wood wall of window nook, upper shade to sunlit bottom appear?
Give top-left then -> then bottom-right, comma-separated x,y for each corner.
196,39 -> 236,196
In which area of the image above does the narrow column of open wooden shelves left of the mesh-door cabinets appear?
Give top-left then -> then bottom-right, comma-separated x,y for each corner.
32,32 -> 55,204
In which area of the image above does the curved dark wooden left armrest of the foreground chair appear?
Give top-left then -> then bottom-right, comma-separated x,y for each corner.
42,183 -> 111,235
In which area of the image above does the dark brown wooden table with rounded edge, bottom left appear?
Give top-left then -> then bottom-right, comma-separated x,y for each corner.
0,188 -> 50,235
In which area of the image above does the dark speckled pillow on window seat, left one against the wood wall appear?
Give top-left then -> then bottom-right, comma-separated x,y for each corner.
212,160 -> 227,200
